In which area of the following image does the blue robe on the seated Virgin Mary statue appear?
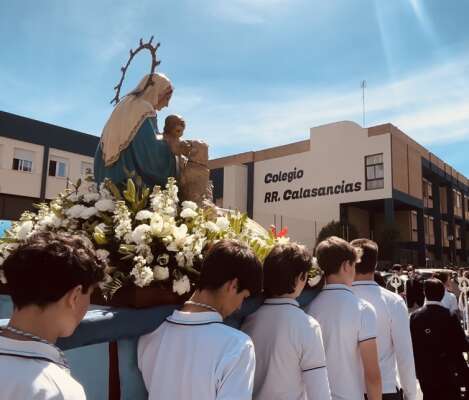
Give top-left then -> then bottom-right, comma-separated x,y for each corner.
94,118 -> 176,189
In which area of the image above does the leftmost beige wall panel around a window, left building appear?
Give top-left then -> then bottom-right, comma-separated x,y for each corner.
0,136 -> 44,197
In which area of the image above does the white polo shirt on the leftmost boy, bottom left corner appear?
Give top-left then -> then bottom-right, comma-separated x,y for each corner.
0,336 -> 86,400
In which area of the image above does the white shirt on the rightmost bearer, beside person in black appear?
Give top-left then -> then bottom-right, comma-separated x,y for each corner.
352,281 -> 417,400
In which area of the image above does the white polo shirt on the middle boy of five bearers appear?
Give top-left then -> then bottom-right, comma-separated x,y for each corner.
241,298 -> 331,400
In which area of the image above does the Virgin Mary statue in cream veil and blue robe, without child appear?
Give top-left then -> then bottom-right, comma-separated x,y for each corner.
94,73 -> 176,188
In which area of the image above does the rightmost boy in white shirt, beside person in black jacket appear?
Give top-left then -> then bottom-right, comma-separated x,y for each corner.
351,239 -> 417,400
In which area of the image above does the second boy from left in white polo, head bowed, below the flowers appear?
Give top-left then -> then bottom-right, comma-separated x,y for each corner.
138,240 -> 262,400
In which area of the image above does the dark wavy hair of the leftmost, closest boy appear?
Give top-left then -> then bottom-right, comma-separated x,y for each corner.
3,232 -> 104,309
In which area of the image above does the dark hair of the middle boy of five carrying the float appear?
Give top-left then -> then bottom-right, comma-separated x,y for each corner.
264,243 -> 312,297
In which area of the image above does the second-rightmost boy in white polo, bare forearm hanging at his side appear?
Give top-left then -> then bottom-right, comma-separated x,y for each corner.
307,236 -> 381,400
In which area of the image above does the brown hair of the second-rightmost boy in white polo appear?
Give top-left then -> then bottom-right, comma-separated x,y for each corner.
316,236 -> 358,276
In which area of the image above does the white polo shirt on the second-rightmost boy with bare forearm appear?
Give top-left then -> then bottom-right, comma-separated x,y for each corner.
307,284 -> 376,400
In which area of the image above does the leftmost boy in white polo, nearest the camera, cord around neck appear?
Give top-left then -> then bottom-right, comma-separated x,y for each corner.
0,233 -> 103,400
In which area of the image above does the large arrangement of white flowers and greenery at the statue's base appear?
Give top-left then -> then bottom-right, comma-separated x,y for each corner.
0,178 -> 308,297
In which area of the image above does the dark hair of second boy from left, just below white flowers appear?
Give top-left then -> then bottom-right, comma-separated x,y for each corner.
198,240 -> 262,296
